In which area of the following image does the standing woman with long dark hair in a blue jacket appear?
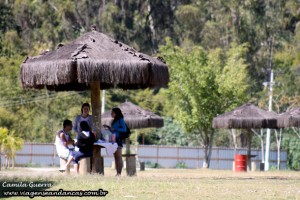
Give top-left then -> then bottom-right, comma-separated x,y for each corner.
106,108 -> 127,176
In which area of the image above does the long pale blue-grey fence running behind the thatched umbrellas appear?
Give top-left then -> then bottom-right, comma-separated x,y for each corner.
1,143 -> 287,169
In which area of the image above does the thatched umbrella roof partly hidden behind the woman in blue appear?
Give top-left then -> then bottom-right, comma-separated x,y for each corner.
101,102 -> 164,129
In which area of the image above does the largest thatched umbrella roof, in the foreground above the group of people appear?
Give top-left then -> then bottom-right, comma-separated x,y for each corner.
20,30 -> 169,91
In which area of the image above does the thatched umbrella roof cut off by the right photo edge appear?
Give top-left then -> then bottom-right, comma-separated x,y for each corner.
277,107 -> 300,128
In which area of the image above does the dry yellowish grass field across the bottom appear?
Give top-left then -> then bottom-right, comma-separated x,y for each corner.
0,168 -> 300,200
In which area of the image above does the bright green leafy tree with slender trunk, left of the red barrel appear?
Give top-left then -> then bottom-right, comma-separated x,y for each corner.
160,38 -> 247,168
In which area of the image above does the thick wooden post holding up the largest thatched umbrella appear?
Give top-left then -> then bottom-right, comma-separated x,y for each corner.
90,81 -> 104,174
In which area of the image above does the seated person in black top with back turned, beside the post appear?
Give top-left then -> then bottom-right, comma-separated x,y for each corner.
60,121 -> 95,174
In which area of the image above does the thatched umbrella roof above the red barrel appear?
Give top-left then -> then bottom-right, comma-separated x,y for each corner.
213,104 -> 277,129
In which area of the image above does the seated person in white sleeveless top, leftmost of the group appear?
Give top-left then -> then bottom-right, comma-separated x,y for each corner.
55,119 -> 74,160
